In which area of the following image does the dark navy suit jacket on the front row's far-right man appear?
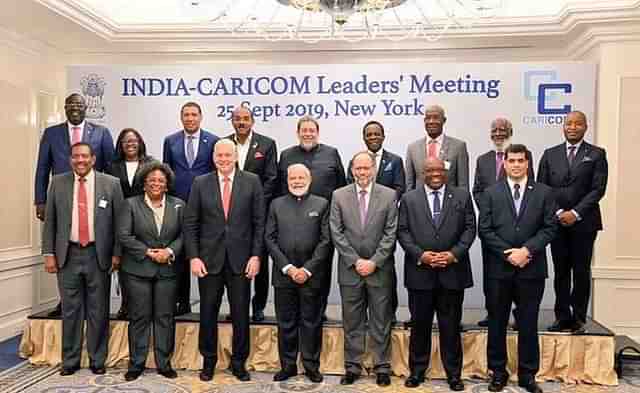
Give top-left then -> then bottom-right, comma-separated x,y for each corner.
478,179 -> 558,279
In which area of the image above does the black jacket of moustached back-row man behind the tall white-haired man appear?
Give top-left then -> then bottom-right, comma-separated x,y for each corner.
227,131 -> 278,206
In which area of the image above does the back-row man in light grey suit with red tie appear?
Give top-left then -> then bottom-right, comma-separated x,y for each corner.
406,105 -> 469,191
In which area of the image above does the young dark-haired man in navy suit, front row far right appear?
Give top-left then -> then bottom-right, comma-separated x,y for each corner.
478,144 -> 557,393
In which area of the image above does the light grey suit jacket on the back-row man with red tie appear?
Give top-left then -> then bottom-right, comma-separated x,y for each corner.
406,135 -> 469,190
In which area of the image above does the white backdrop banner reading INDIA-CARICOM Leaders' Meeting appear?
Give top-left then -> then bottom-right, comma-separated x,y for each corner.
67,63 -> 596,307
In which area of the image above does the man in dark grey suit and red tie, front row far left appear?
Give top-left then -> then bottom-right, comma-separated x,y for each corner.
42,142 -> 124,375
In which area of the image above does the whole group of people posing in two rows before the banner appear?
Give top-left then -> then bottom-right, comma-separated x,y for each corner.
35,94 -> 608,393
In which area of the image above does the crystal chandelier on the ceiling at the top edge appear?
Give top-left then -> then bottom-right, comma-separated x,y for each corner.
180,0 -> 506,43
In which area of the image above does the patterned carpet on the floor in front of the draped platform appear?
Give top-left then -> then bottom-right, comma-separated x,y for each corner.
0,361 -> 640,393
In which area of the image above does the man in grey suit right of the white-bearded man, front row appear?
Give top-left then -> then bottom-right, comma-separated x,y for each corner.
329,151 -> 398,386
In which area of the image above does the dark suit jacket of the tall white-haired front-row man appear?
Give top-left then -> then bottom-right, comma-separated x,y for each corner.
183,170 -> 266,274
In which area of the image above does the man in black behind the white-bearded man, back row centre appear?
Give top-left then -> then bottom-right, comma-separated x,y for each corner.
278,116 -> 347,320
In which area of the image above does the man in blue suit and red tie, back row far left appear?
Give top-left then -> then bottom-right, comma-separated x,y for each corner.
34,93 -> 115,317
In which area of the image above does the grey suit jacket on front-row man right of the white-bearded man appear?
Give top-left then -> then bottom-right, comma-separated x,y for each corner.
329,184 -> 398,286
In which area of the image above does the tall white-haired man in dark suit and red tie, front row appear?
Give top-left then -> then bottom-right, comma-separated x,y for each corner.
183,139 -> 265,381
